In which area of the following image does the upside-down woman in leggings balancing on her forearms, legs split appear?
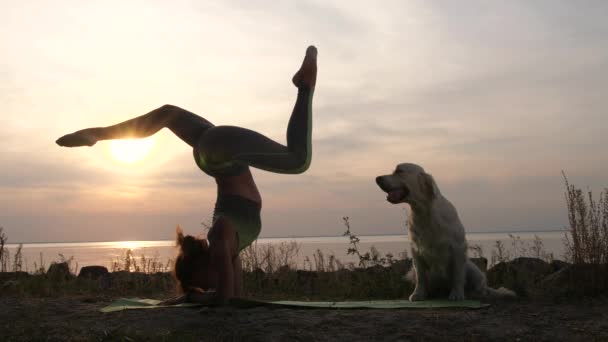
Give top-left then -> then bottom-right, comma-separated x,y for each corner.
57,46 -> 317,304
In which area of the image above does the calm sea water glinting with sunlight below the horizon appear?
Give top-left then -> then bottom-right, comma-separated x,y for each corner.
2,231 -> 564,271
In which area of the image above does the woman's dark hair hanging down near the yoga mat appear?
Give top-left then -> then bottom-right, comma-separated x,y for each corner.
173,226 -> 209,292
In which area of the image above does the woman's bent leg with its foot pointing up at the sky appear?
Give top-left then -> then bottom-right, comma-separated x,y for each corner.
196,46 -> 317,173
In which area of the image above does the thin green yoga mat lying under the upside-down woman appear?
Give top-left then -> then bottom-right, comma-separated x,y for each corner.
100,298 -> 488,312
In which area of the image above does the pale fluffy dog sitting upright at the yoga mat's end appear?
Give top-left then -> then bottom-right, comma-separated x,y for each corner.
376,163 -> 515,301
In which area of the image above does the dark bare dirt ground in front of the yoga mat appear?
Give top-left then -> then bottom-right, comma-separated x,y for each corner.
0,297 -> 608,342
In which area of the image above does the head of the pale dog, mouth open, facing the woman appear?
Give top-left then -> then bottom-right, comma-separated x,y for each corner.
376,163 -> 439,204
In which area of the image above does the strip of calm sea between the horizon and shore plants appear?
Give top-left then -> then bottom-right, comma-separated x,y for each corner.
5,231 -> 566,272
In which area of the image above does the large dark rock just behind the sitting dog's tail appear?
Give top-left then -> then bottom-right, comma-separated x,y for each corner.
486,258 -> 553,297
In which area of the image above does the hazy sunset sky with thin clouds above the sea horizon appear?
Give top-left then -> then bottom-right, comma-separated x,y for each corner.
0,0 -> 608,242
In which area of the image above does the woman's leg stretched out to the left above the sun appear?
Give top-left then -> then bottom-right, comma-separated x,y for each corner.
57,105 -> 213,147
